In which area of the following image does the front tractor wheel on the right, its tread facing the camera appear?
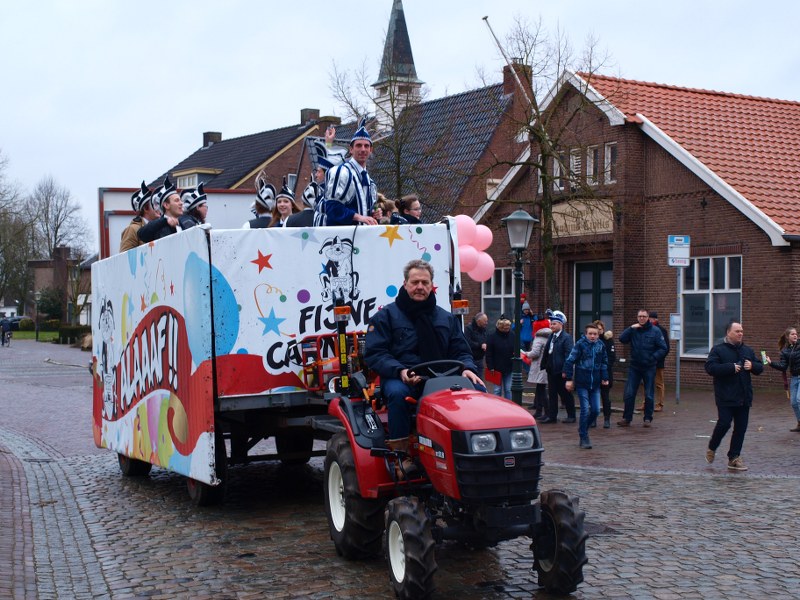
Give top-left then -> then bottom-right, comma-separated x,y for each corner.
531,490 -> 588,595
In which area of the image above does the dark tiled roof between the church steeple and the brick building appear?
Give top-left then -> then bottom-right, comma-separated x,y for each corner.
369,84 -> 512,222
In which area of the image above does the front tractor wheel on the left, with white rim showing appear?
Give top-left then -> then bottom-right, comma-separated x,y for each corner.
384,496 -> 438,600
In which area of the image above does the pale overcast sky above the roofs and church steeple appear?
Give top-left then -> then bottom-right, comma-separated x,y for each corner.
0,0 -> 800,251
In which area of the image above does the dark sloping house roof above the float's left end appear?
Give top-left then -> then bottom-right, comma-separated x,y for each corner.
150,123 -> 315,189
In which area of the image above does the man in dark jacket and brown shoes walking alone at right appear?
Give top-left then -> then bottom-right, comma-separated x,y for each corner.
706,321 -> 764,471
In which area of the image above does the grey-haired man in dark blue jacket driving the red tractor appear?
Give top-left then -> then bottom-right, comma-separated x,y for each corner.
364,260 -> 485,470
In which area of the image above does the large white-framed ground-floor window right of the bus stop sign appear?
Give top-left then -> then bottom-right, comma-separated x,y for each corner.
680,254 -> 744,358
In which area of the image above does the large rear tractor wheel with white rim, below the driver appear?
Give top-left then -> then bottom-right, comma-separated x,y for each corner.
322,433 -> 384,560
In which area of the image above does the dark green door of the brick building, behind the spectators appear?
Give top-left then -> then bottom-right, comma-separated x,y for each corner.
574,262 -> 614,337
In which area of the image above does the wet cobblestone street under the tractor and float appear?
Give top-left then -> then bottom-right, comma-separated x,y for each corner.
0,341 -> 800,600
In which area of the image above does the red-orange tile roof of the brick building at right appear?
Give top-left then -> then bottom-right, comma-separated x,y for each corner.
580,74 -> 800,240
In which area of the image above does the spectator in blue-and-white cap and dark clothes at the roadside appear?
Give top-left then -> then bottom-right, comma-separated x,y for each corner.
539,310 -> 575,424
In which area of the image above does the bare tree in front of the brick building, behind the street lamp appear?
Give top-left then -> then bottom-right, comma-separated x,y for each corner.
482,17 -> 620,308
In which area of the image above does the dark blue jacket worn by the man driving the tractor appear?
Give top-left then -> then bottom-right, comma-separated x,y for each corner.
364,302 -> 478,379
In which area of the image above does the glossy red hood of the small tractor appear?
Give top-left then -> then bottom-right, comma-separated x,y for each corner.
417,390 -> 536,431
